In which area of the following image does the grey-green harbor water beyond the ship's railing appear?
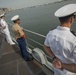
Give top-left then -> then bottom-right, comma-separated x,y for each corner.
6,0 -> 76,49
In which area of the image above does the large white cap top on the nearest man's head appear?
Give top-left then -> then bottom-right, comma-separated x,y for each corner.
54,4 -> 76,17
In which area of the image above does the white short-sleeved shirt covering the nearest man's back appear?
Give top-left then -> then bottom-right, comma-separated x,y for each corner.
45,26 -> 76,75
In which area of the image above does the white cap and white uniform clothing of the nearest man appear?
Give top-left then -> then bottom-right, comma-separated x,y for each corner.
44,4 -> 76,75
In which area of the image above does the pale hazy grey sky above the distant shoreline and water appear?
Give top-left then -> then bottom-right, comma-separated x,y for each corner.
0,0 -> 61,9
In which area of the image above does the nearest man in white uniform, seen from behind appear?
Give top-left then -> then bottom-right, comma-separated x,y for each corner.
44,4 -> 76,75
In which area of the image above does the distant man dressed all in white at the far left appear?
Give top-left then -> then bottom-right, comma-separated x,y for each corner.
0,14 -> 15,45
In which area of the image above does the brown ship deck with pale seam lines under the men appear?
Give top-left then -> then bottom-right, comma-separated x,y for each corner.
0,34 -> 53,75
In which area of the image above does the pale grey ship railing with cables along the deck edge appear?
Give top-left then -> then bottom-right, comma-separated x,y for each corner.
8,23 -> 53,71
